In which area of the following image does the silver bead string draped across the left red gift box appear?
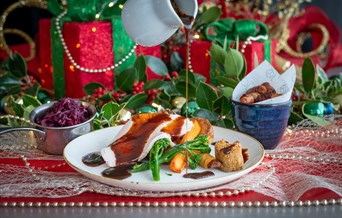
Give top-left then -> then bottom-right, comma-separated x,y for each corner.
56,10 -> 137,73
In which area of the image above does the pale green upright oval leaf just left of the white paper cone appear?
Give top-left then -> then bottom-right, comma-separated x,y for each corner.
224,49 -> 244,78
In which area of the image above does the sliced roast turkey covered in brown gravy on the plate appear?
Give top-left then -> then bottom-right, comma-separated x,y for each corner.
101,113 -> 193,167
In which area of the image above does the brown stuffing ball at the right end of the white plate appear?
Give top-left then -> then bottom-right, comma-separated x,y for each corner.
215,139 -> 248,172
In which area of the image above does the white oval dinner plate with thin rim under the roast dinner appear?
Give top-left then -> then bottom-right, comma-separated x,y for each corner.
64,126 -> 265,191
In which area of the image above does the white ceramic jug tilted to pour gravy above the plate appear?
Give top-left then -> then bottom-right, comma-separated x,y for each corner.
121,0 -> 198,46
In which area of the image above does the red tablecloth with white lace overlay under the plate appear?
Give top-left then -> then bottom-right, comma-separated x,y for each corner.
0,115 -> 342,206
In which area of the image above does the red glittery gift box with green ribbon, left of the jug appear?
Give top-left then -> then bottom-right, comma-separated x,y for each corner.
36,19 -> 161,98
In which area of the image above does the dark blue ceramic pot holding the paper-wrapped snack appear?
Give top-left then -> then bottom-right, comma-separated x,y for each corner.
232,101 -> 292,149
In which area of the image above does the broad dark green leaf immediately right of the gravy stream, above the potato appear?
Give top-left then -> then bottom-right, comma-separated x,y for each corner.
196,82 -> 217,110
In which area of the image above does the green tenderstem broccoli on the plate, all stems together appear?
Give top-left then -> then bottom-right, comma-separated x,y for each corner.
130,135 -> 211,181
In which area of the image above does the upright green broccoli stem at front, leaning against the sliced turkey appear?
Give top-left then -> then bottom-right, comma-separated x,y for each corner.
149,138 -> 170,181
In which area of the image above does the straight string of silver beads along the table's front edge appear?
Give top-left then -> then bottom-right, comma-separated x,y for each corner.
0,198 -> 342,208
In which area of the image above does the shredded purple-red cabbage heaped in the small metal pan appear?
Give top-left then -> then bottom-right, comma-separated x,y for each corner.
37,98 -> 92,127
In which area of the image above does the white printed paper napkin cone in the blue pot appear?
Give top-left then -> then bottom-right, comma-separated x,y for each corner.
233,61 -> 296,104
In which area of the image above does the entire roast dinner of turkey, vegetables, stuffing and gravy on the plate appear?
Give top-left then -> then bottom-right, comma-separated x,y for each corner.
82,112 -> 248,181
